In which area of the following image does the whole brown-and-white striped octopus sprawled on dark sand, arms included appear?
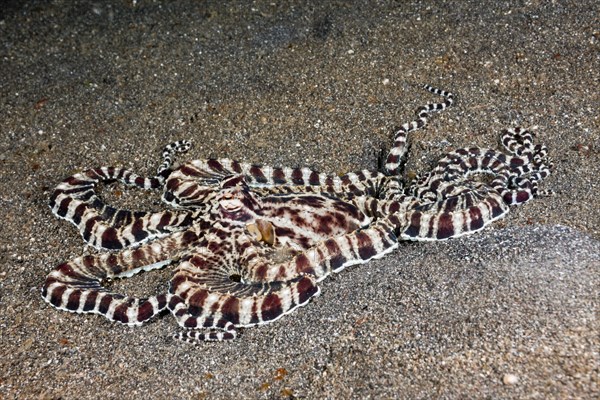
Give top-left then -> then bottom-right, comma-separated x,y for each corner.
42,86 -> 551,343
